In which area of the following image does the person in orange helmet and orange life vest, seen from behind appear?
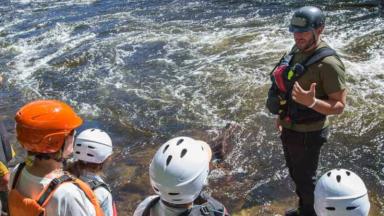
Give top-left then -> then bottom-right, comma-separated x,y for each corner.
9,100 -> 103,216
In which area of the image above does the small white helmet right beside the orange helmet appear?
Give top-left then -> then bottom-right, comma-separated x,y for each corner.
73,128 -> 112,164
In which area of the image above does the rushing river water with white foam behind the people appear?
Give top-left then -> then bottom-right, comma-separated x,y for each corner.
0,0 -> 384,215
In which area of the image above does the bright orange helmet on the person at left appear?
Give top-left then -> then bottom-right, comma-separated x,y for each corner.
15,100 -> 83,153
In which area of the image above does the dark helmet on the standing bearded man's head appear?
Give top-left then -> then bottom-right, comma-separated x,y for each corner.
289,6 -> 325,32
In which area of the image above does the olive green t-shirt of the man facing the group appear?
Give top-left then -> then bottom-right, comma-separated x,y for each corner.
280,41 -> 346,132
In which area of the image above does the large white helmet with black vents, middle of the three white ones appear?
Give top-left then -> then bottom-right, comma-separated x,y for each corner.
149,137 -> 212,204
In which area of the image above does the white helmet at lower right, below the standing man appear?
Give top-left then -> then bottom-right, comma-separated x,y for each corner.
315,169 -> 370,216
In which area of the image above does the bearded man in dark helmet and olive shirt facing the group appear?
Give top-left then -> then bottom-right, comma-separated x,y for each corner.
267,6 -> 346,216
